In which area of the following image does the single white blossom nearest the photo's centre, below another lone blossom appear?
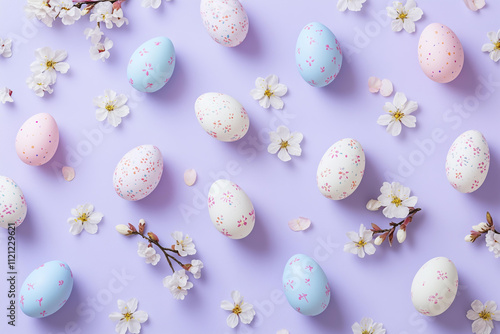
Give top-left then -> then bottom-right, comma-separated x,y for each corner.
267,125 -> 304,161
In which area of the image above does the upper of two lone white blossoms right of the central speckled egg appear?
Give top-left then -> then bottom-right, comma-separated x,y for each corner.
250,74 -> 288,109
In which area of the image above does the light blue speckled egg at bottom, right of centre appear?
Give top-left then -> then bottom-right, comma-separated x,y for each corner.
283,254 -> 330,316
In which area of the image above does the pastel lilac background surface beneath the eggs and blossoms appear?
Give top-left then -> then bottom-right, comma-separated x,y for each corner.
0,0 -> 500,334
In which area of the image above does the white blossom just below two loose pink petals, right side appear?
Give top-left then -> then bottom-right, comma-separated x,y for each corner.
377,92 -> 418,136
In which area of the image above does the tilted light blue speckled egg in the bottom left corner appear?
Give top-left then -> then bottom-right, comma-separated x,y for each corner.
19,261 -> 73,318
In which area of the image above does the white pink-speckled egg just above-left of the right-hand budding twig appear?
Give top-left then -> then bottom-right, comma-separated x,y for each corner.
316,138 -> 365,200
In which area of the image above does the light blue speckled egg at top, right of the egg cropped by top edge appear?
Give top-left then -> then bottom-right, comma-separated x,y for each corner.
295,22 -> 342,87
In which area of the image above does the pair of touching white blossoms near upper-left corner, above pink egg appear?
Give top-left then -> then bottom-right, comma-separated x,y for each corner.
26,47 -> 69,97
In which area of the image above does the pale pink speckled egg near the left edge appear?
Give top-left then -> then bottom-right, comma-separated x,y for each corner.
16,113 -> 59,166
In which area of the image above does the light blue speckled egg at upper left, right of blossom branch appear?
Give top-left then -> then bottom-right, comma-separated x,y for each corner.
127,37 -> 175,93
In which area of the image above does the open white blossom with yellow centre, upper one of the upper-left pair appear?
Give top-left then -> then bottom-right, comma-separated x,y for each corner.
30,46 -> 69,84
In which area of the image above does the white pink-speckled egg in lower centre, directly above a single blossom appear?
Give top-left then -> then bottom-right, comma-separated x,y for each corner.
208,180 -> 255,239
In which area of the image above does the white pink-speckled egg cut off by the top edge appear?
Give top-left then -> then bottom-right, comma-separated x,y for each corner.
200,0 -> 248,47
